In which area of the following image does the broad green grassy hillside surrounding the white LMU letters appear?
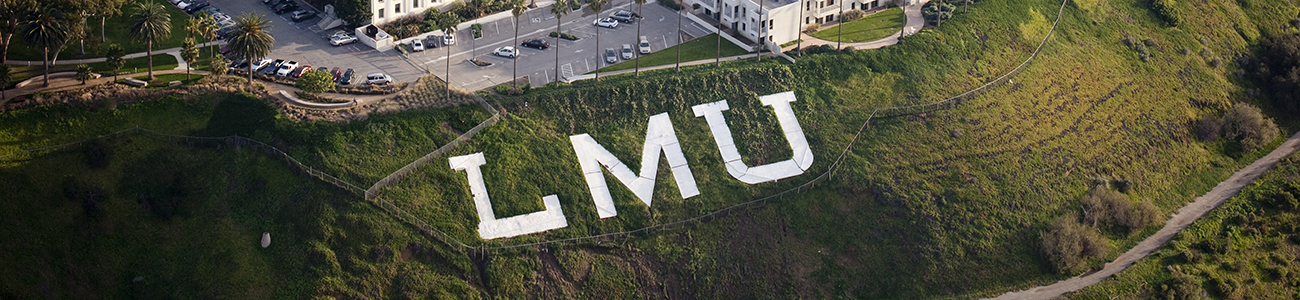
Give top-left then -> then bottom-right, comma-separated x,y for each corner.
0,0 -> 1300,299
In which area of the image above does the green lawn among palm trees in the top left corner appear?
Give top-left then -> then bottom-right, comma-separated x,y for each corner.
8,0 -> 203,61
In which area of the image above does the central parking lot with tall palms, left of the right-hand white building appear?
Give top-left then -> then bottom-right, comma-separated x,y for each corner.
411,0 -> 707,91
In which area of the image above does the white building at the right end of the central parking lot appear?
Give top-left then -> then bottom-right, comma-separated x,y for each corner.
685,0 -> 893,45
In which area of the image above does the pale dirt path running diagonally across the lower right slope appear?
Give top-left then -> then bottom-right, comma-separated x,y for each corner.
995,132 -> 1300,299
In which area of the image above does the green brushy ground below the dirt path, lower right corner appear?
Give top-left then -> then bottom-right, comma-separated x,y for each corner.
1069,155 -> 1300,299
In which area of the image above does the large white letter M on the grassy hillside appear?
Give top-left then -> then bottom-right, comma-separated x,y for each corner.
569,113 -> 699,218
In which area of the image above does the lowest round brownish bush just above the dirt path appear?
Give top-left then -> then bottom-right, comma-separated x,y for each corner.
1040,217 -> 1110,273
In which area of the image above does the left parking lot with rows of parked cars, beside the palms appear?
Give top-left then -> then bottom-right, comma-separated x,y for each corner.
209,0 -> 424,83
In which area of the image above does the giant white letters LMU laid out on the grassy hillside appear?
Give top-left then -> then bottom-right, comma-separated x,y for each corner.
447,92 -> 813,239
